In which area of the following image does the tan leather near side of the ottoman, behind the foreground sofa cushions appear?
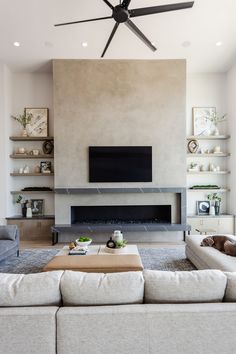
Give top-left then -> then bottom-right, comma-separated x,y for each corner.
44,254 -> 143,273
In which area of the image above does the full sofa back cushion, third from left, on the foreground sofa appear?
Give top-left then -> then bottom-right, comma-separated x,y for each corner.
144,270 -> 227,303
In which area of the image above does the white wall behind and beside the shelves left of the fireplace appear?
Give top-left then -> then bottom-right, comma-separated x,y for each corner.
0,70 -> 54,217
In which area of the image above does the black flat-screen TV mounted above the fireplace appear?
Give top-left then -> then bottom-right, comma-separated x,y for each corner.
89,146 -> 152,182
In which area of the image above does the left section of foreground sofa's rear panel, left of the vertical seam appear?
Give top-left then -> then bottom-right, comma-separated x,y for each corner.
0,306 -> 58,354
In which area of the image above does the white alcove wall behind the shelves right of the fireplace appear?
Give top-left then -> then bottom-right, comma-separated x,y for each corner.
186,73 -> 228,215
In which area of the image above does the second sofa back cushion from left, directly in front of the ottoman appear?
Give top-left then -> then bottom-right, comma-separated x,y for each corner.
61,270 -> 144,306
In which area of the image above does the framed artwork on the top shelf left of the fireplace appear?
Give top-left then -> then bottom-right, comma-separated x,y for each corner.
25,108 -> 49,137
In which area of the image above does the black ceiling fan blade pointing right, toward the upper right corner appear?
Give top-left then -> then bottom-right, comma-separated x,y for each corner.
129,1 -> 194,17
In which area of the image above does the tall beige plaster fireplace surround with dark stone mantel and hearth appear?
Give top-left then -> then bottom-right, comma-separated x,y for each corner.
53,60 -> 186,242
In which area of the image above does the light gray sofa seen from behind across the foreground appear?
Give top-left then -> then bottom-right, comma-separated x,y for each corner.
0,270 -> 236,354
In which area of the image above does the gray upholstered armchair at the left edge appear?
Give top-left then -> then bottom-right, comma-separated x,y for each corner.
0,225 -> 20,262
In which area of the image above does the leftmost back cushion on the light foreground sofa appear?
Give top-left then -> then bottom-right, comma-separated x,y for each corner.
0,271 -> 63,307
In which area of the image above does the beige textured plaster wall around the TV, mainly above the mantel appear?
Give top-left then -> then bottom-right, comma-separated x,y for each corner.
53,60 -> 186,231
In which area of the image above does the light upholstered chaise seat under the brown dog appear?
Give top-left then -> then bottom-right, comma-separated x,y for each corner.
186,235 -> 236,272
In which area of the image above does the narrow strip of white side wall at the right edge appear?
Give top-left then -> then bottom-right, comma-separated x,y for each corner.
226,64 -> 236,214
